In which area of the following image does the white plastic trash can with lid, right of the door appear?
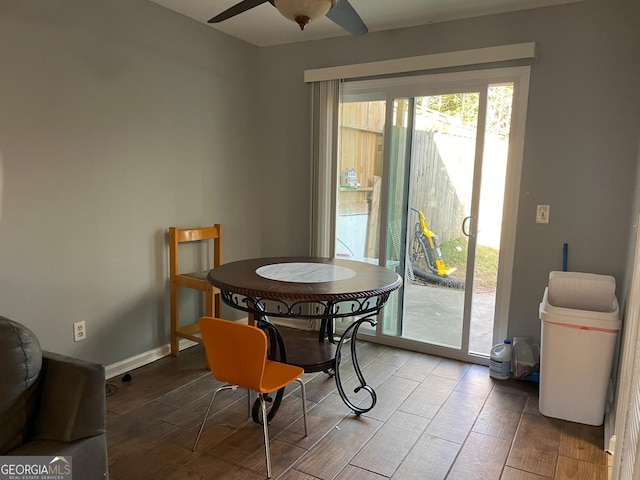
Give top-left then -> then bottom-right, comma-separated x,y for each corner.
539,272 -> 622,425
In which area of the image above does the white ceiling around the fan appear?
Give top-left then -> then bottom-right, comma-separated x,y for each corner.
151,0 -> 582,47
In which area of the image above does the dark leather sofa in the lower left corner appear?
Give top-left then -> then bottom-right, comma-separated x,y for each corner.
0,316 -> 108,480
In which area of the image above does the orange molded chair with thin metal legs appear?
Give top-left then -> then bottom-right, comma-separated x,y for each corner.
193,317 -> 308,478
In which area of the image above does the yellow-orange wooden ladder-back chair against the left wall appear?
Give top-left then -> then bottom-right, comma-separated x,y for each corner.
169,224 -> 222,357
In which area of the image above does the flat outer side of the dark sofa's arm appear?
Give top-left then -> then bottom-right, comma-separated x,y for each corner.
33,352 -> 106,442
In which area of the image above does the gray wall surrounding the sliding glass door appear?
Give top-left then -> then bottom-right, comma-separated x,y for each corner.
260,0 -> 640,338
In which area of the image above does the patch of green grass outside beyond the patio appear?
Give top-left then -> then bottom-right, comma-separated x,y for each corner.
440,237 -> 500,290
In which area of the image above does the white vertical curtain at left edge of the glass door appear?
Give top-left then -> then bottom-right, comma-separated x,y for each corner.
310,80 -> 340,257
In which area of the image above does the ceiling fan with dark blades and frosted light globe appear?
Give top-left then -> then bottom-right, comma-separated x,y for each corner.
207,0 -> 369,35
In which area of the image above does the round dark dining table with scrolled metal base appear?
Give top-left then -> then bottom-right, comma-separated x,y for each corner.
207,257 -> 402,420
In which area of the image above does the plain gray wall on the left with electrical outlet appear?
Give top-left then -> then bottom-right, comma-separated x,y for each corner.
0,0 -> 260,364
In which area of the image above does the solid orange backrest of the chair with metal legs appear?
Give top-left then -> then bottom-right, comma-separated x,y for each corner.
199,317 -> 267,391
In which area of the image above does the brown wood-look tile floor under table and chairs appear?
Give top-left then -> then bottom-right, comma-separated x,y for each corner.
107,336 -> 607,480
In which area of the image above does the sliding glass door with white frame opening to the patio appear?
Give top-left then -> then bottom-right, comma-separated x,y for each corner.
335,65 -> 528,363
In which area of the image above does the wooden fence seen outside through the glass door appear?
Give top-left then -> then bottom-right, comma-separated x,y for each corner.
338,102 -> 465,257
